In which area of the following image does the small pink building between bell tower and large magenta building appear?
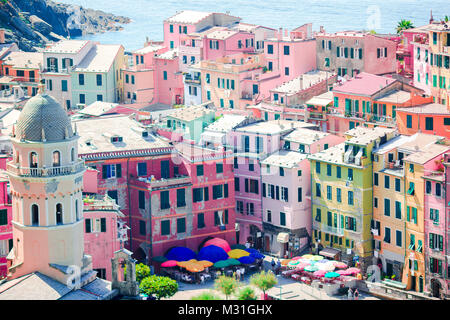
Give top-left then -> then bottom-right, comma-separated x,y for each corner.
83,197 -> 128,281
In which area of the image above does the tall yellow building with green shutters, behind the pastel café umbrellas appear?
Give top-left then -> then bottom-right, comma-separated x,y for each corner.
308,127 -> 395,270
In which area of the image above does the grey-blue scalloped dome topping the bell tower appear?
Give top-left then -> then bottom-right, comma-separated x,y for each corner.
15,94 -> 73,141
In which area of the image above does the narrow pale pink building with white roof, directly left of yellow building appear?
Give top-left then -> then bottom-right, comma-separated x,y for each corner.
261,128 -> 345,257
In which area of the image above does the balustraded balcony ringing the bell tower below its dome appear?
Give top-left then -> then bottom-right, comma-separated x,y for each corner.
7,159 -> 85,178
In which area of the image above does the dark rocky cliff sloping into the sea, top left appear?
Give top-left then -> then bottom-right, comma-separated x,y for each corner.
0,0 -> 130,51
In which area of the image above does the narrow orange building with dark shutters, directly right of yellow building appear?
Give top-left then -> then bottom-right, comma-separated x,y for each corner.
371,133 -> 443,281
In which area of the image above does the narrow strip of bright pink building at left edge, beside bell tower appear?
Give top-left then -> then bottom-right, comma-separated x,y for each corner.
0,174 -> 13,278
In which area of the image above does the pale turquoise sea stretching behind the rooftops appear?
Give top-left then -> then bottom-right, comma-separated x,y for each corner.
55,0 -> 450,51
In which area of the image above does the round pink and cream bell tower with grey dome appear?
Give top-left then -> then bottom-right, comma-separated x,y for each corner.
7,92 -> 89,284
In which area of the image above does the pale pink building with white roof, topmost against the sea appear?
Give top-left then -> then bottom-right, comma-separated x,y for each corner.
164,10 -> 241,49
